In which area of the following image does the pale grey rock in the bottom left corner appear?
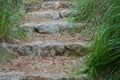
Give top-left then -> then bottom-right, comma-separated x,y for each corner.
0,71 -> 25,80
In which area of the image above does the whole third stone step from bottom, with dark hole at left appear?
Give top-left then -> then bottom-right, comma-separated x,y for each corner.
20,21 -> 84,34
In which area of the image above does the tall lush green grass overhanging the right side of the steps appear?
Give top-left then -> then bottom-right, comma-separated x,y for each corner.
71,0 -> 120,80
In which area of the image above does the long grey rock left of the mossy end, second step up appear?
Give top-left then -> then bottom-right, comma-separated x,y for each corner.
14,42 -> 64,56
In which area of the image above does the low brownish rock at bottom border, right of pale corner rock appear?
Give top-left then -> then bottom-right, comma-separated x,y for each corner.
24,73 -> 87,80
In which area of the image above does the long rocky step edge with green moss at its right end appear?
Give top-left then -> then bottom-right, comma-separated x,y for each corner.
3,41 -> 90,57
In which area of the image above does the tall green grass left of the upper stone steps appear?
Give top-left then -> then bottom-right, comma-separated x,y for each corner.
0,0 -> 23,42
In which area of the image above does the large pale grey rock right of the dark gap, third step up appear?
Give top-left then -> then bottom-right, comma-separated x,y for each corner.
34,21 -> 68,34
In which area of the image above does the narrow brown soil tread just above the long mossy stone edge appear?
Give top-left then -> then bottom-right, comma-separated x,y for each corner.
29,33 -> 89,43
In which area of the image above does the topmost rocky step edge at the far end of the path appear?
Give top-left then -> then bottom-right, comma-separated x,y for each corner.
25,0 -> 73,12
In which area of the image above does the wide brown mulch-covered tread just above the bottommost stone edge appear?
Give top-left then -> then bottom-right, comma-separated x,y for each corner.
0,56 -> 82,74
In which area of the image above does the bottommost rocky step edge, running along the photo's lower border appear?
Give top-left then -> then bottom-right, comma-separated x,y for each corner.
0,71 -> 87,80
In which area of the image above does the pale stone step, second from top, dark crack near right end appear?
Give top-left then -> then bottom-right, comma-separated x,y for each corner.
26,9 -> 72,19
